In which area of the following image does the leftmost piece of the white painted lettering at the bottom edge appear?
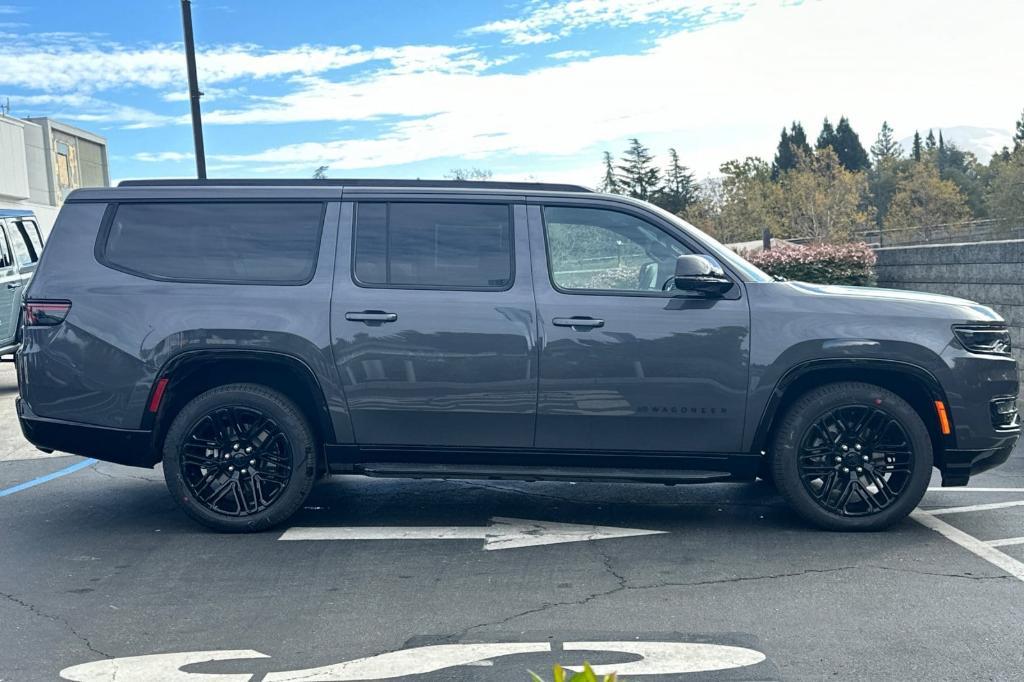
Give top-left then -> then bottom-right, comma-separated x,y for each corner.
60,649 -> 269,682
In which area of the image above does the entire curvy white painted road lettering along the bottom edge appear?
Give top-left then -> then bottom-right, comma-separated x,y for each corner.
60,641 -> 765,682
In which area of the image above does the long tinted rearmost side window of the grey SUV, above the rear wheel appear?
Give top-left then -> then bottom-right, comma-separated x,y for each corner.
103,202 -> 323,284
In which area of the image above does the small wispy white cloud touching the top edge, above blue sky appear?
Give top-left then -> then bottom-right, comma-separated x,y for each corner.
468,0 -> 751,45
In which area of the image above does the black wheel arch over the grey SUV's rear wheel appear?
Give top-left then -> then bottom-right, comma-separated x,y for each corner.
142,349 -> 335,466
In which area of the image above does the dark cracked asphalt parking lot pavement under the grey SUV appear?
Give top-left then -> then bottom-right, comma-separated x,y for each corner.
0,358 -> 1024,682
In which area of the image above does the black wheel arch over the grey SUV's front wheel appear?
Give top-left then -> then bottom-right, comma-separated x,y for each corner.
751,358 -> 956,461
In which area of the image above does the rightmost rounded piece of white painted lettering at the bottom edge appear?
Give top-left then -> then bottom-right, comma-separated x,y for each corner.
562,642 -> 765,677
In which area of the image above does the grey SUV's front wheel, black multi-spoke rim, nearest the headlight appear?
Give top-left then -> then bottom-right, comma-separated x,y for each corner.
773,382 -> 933,530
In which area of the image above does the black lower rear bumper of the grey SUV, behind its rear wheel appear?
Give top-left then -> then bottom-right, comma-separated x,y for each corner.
15,398 -> 159,468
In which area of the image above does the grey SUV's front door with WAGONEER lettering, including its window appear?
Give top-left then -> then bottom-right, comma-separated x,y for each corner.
529,203 -> 750,453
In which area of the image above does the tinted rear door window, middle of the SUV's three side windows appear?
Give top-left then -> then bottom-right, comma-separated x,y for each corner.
354,203 -> 512,289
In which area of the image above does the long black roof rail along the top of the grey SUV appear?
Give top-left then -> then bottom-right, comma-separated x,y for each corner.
118,178 -> 593,193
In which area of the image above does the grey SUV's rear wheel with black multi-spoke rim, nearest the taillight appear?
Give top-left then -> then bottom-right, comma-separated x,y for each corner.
164,384 -> 316,532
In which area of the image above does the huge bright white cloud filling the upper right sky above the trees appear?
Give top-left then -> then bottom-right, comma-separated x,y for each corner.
197,0 -> 1024,182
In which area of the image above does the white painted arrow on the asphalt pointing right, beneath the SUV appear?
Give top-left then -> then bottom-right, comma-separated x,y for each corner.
279,518 -> 666,550
